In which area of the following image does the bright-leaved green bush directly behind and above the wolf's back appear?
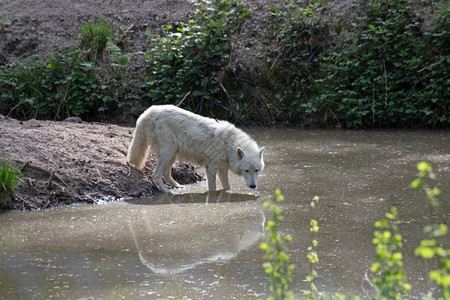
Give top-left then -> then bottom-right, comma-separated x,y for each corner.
146,0 -> 249,116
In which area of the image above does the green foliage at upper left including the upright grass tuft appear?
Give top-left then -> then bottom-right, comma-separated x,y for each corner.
0,23 -> 134,120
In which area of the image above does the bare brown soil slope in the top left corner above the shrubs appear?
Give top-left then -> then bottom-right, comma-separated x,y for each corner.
0,0 -> 194,63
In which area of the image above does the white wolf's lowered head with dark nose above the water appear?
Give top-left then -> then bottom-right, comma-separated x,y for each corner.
236,147 -> 264,189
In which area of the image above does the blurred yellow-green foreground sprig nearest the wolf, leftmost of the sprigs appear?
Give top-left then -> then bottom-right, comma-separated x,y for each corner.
259,189 -> 295,300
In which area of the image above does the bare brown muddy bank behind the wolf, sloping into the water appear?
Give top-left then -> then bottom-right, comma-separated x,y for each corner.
0,115 -> 202,209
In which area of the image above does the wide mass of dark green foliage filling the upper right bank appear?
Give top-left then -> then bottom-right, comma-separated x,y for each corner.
264,0 -> 450,128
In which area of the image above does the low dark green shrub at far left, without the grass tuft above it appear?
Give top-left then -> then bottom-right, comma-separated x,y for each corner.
0,51 -> 130,120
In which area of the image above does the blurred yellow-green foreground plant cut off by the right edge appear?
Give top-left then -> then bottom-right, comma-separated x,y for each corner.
411,162 -> 450,299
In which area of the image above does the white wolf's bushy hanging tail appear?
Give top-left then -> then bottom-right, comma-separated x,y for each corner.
127,122 -> 149,170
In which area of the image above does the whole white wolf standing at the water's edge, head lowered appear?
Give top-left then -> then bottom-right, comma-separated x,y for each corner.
127,105 -> 264,193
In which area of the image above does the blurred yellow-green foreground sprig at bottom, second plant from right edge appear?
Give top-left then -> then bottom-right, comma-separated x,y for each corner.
372,207 -> 411,300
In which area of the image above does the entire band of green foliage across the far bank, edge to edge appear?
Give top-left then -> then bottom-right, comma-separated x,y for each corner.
0,0 -> 450,128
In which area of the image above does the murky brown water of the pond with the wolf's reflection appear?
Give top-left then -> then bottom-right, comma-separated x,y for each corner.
0,129 -> 450,299
